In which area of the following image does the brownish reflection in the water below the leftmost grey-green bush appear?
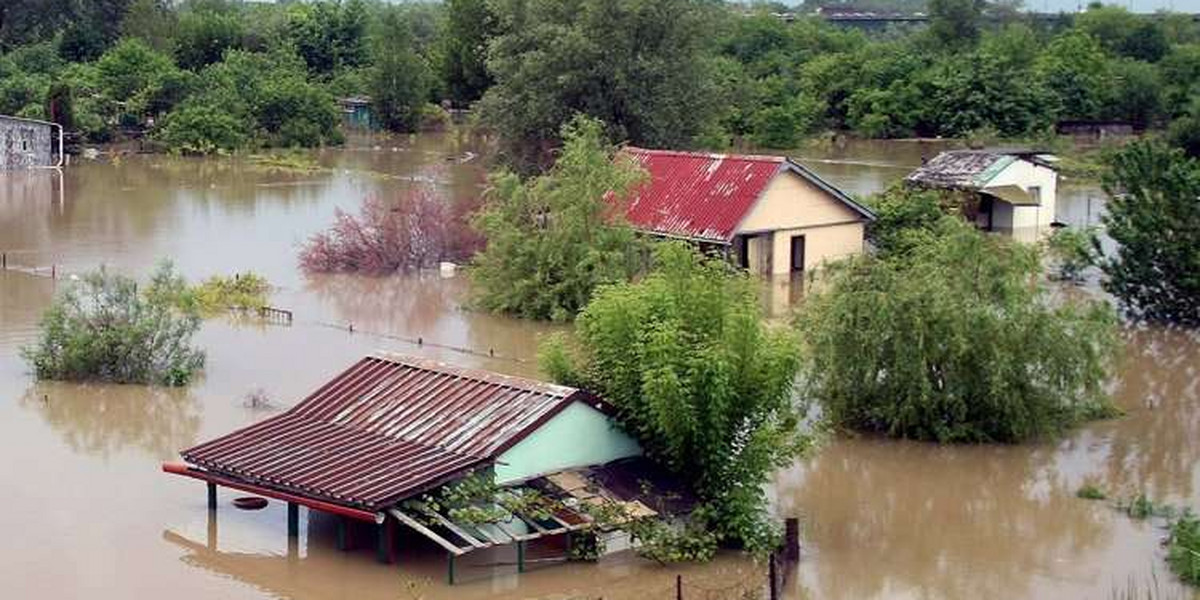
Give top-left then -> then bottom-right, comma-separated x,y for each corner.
18,382 -> 200,458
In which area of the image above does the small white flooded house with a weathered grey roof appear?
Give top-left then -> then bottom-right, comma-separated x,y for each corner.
905,150 -> 1058,241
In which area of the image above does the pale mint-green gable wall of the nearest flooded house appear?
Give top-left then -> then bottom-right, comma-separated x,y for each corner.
496,402 -> 642,484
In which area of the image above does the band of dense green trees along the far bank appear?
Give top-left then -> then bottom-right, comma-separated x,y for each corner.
0,0 -> 1200,159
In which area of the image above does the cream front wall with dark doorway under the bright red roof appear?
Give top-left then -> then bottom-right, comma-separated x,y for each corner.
738,166 -> 865,275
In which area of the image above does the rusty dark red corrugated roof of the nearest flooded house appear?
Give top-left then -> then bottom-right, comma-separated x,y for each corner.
181,355 -> 583,510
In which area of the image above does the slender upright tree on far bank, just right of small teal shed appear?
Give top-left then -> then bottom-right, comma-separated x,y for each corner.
370,12 -> 430,132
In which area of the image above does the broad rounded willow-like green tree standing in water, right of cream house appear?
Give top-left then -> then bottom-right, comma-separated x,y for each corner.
798,217 -> 1117,442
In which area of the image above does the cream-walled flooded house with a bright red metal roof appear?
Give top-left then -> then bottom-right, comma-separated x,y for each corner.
623,148 -> 875,275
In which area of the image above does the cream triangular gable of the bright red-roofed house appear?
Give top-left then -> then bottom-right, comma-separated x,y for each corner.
737,169 -> 864,233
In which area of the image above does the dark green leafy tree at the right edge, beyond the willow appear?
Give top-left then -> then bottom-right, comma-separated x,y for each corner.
1100,140 -> 1200,326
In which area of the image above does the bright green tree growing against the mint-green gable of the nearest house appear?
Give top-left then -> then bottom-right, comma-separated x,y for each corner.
541,242 -> 811,552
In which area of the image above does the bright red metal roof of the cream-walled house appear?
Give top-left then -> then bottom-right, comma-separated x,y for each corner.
623,146 -> 874,244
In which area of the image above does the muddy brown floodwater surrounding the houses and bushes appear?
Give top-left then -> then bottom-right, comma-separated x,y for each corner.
0,136 -> 1200,600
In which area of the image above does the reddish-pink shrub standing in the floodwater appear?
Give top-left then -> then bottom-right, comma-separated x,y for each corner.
300,186 -> 474,275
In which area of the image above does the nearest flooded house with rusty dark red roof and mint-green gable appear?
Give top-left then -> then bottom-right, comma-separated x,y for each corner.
163,354 -> 676,583
